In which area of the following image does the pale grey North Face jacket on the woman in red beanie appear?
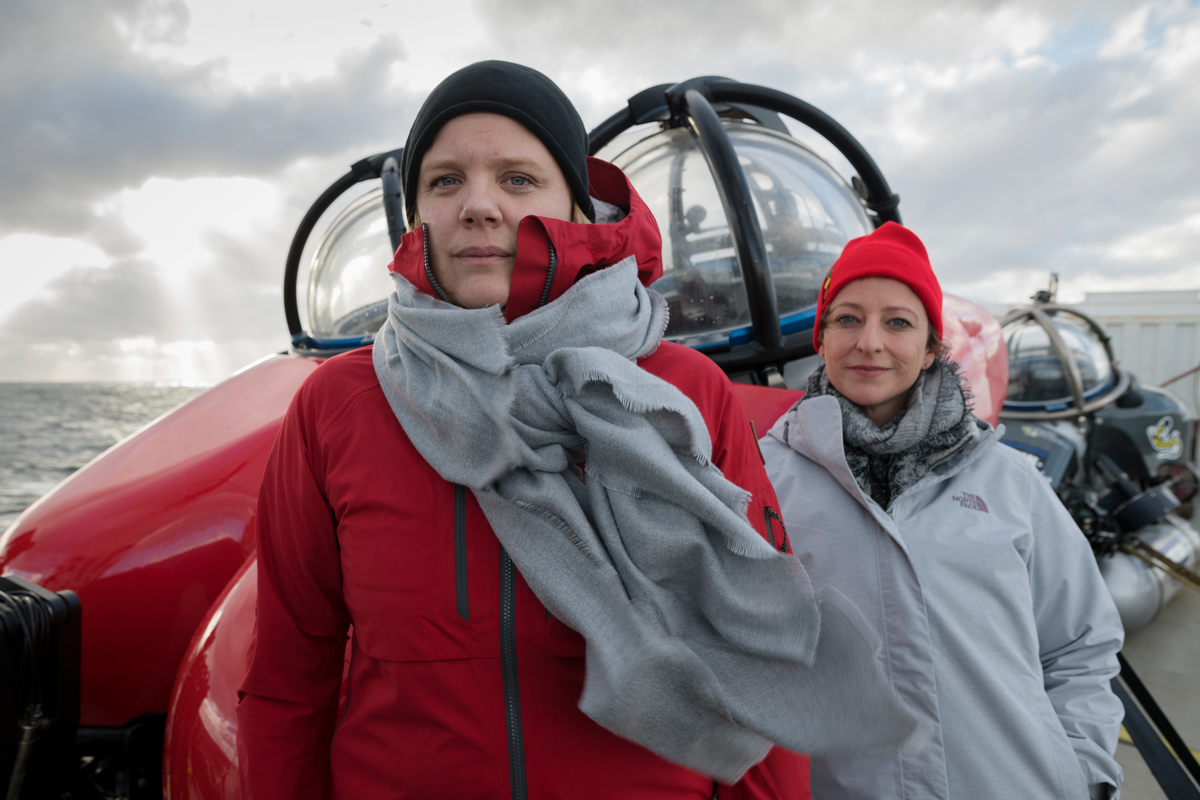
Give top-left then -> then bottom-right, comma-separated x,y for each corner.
761,396 -> 1123,800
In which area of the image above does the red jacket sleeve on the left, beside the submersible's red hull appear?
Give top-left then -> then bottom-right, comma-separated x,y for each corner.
238,387 -> 349,800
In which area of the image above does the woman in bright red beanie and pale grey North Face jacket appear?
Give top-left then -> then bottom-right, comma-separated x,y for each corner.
762,223 -> 1123,800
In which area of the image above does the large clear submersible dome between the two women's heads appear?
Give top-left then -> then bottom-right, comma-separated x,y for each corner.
612,120 -> 874,345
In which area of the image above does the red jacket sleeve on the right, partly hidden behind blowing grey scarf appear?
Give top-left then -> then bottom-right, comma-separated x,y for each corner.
701,385 -> 811,800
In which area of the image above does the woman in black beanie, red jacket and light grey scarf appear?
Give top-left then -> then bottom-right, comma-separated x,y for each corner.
238,62 -> 902,800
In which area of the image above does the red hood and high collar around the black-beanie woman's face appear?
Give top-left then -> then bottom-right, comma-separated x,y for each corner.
388,157 -> 662,321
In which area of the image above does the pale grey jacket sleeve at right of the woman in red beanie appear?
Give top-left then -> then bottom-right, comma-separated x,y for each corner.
1028,469 -> 1124,790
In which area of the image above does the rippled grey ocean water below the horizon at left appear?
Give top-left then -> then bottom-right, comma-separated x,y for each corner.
0,383 -> 206,520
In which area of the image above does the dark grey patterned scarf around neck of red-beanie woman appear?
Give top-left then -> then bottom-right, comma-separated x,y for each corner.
804,359 -> 979,510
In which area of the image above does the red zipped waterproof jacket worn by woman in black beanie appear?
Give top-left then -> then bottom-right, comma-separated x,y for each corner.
238,161 -> 809,800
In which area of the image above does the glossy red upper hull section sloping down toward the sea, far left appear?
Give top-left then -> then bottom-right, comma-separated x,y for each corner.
0,356 -> 317,726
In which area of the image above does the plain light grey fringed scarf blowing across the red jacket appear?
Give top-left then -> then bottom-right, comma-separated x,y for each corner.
374,258 -> 912,782
